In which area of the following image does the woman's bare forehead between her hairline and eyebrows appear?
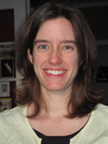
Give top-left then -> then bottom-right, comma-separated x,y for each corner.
36,18 -> 74,40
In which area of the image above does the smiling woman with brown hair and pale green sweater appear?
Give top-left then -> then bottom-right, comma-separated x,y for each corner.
0,3 -> 108,144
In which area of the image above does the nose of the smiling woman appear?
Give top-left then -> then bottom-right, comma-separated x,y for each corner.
49,50 -> 61,65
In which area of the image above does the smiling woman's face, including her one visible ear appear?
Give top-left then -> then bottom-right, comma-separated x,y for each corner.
28,18 -> 79,91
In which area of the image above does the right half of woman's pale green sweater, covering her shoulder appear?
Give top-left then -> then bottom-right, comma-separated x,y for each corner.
71,104 -> 108,144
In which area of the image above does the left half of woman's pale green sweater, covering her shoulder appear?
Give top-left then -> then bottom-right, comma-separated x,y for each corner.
0,107 -> 38,144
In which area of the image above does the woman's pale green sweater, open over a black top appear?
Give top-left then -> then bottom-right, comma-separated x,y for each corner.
0,104 -> 108,144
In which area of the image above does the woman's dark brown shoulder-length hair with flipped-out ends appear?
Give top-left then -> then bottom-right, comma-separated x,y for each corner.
16,3 -> 102,117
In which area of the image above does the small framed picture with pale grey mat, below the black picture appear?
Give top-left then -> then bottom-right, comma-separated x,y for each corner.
0,82 -> 10,97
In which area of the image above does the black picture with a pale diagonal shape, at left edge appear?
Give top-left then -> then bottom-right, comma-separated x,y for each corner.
1,58 -> 14,78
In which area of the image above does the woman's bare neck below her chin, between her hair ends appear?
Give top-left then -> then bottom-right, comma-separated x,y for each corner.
42,86 -> 70,117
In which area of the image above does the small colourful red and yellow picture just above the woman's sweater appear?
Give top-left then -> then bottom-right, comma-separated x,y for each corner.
0,98 -> 12,112
